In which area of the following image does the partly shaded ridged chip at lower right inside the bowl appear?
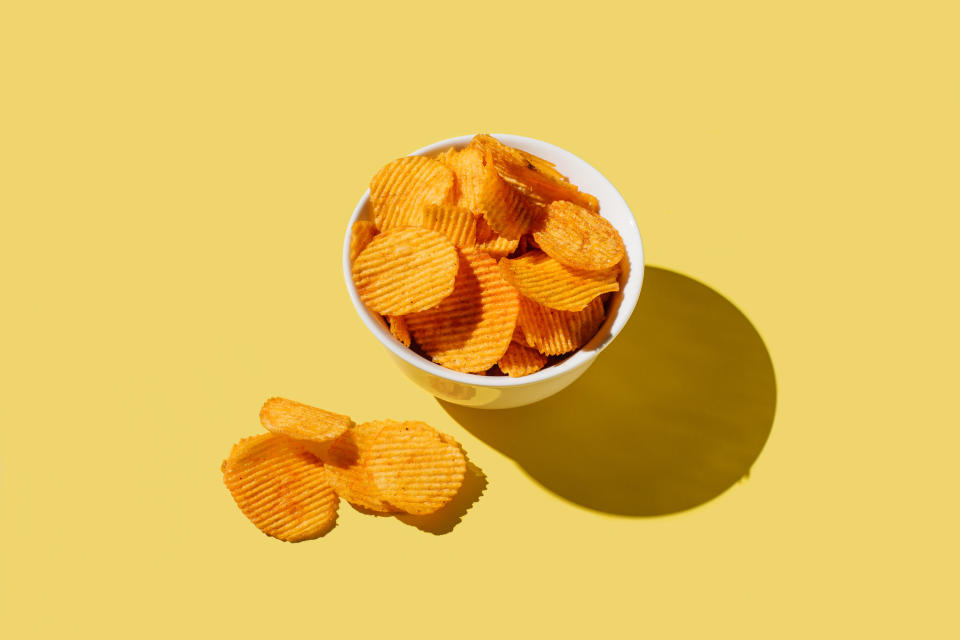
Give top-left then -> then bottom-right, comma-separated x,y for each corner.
520,296 -> 605,356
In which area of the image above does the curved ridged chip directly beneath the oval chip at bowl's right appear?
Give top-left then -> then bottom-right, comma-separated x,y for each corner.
500,251 -> 620,311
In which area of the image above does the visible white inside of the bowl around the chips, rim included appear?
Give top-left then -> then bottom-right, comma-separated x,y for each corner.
343,133 -> 643,387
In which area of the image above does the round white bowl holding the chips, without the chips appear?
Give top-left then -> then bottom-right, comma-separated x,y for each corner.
343,134 -> 643,409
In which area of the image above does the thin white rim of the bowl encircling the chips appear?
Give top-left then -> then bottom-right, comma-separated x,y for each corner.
342,133 -> 644,389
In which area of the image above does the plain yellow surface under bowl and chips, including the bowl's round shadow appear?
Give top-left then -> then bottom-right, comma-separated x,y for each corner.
0,2 -> 960,639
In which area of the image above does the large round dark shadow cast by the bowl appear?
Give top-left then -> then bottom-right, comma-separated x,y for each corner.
439,267 -> 777,516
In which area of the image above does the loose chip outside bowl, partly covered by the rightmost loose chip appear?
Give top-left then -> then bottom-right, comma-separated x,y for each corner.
324,420 -> 398,513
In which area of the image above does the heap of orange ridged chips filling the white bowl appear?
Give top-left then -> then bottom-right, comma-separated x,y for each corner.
350,134 -> 626,376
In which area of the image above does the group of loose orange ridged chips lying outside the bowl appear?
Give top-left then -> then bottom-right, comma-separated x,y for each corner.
220,398 -> 467,542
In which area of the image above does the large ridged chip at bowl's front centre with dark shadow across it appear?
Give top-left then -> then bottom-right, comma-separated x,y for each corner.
406,249 -> 519,373
